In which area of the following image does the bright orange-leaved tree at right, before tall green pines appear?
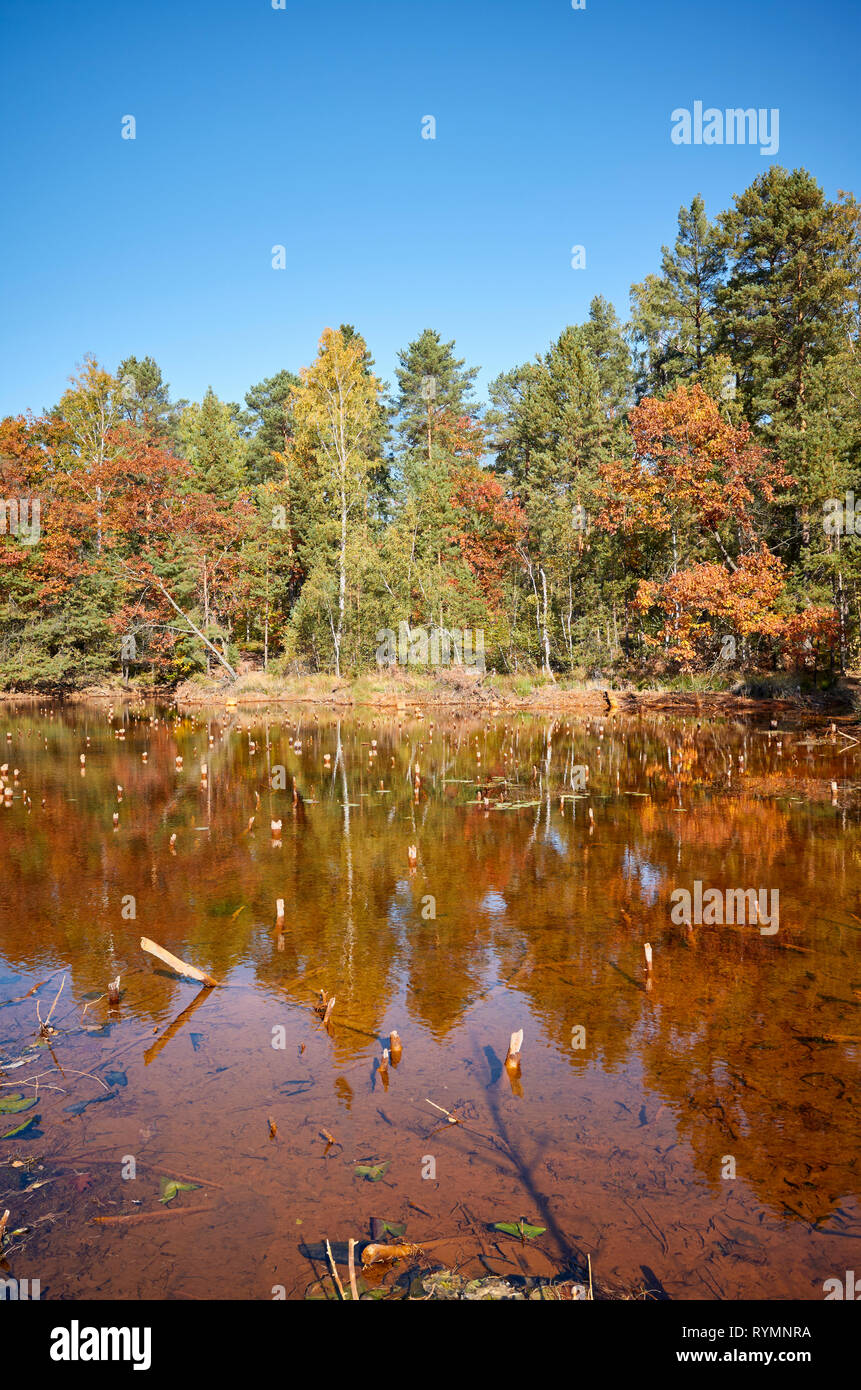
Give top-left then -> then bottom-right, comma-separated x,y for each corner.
597,385 -> 830,670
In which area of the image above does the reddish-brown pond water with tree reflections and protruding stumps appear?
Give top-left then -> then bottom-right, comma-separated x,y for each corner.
0,706 -> 861,1300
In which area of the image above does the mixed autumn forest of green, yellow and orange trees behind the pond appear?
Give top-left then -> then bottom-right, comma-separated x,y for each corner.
0,165 -> 861,691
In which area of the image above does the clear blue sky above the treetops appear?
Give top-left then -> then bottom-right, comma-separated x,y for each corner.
0,0 -> 861,414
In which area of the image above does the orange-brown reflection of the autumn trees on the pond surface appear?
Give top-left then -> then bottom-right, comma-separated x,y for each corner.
0,709 -> 861,1219
